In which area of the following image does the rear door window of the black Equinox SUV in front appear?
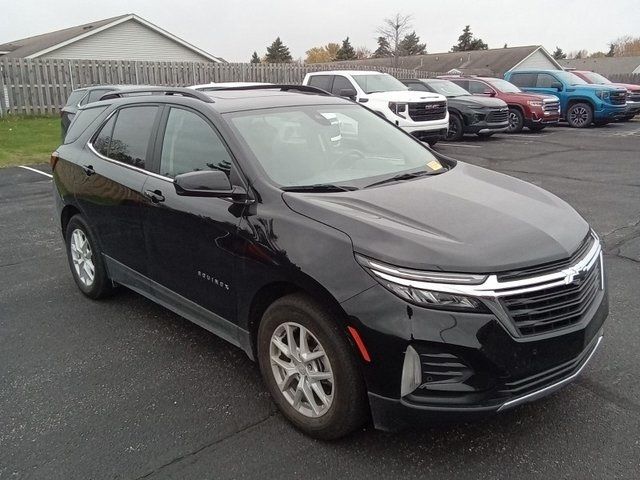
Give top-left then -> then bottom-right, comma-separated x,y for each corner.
93,105 -> 158,168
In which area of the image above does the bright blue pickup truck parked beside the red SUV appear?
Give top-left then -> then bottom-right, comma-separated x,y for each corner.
504,70 -> 627,128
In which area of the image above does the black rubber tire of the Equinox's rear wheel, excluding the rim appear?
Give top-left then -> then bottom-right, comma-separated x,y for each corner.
64,214 -> 114,299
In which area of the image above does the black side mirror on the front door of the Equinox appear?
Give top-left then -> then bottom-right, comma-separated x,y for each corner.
173,170 -> 247,200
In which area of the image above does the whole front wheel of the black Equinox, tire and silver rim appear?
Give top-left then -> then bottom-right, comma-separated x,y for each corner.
257,294 -> 367,440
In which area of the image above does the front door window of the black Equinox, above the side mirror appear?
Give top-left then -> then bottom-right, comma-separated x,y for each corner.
160,108 -> 231,177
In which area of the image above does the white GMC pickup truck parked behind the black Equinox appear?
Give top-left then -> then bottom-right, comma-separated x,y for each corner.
302,70 -> 449,145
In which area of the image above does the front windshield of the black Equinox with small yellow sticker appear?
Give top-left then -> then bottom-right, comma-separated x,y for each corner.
226,105 -> 443,188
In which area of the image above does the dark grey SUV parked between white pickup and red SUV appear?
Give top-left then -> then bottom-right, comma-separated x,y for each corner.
401,79 -> 509,141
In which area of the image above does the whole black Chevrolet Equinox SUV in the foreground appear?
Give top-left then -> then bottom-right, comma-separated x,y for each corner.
52,86 -> 608,438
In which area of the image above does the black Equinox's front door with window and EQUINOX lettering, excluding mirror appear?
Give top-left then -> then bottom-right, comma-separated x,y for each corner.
143,105 -> 244,322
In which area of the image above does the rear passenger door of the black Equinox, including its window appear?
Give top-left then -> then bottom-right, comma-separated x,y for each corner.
76,104 -> 160,275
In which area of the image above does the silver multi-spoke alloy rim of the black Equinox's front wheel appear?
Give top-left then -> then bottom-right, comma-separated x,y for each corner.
269,322 -> 335,418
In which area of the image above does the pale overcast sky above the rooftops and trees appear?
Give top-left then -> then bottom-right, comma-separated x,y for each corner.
0,0 -> 640,62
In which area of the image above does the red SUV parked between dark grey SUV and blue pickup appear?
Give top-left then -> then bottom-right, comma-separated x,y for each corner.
443,76 -> 560,133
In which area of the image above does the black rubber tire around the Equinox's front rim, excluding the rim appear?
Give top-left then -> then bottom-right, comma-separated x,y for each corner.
257,294 -> 369,440
